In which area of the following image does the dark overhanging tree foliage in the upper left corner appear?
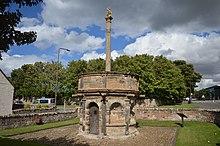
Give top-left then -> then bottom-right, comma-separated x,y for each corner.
0,0 -> 43,59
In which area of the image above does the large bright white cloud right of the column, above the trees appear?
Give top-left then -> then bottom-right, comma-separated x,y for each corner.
124,33 -> 220,87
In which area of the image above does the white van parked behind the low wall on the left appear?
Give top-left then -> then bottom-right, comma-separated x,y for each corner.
31,97 -> 55,107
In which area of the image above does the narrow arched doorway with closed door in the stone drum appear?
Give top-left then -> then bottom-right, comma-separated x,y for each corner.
89,102 -> 99,135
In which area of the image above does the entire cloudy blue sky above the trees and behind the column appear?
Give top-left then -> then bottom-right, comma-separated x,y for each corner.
0,0 -> 220,88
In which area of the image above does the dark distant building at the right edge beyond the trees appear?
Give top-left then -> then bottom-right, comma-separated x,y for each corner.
206,85 -> 220,100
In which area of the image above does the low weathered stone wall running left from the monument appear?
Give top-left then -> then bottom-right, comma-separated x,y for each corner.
0,109 -> 78,130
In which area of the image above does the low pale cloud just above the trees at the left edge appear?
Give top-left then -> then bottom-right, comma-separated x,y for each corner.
0,53 -> 50,76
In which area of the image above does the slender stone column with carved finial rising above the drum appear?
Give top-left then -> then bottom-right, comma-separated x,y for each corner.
105,8 -> 113,72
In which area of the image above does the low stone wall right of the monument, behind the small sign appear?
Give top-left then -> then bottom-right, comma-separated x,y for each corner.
136,108 -> 220,125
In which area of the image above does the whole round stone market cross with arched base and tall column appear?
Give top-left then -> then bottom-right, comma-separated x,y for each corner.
77,8 -> 139,138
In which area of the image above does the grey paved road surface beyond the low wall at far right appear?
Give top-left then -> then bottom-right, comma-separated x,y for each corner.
192,100 -> 220,109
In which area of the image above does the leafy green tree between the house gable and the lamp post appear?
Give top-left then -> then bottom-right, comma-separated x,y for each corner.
11,62 -> 57,98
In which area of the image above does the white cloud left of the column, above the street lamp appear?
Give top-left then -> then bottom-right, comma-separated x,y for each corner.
16,23 -> 105,52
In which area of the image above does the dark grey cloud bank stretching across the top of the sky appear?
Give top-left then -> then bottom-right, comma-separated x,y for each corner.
41,0 -> 220,37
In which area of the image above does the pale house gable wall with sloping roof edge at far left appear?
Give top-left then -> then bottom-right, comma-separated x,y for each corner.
0,69 -> 14,116
